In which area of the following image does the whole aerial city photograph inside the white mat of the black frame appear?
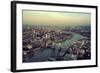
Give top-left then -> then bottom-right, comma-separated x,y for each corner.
22,10 -> 91,63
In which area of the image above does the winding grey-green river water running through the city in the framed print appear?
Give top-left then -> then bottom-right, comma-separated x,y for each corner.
25,33 -> 84,62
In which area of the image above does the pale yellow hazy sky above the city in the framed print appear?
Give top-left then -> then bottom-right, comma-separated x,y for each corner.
22,10 -> 91,26
